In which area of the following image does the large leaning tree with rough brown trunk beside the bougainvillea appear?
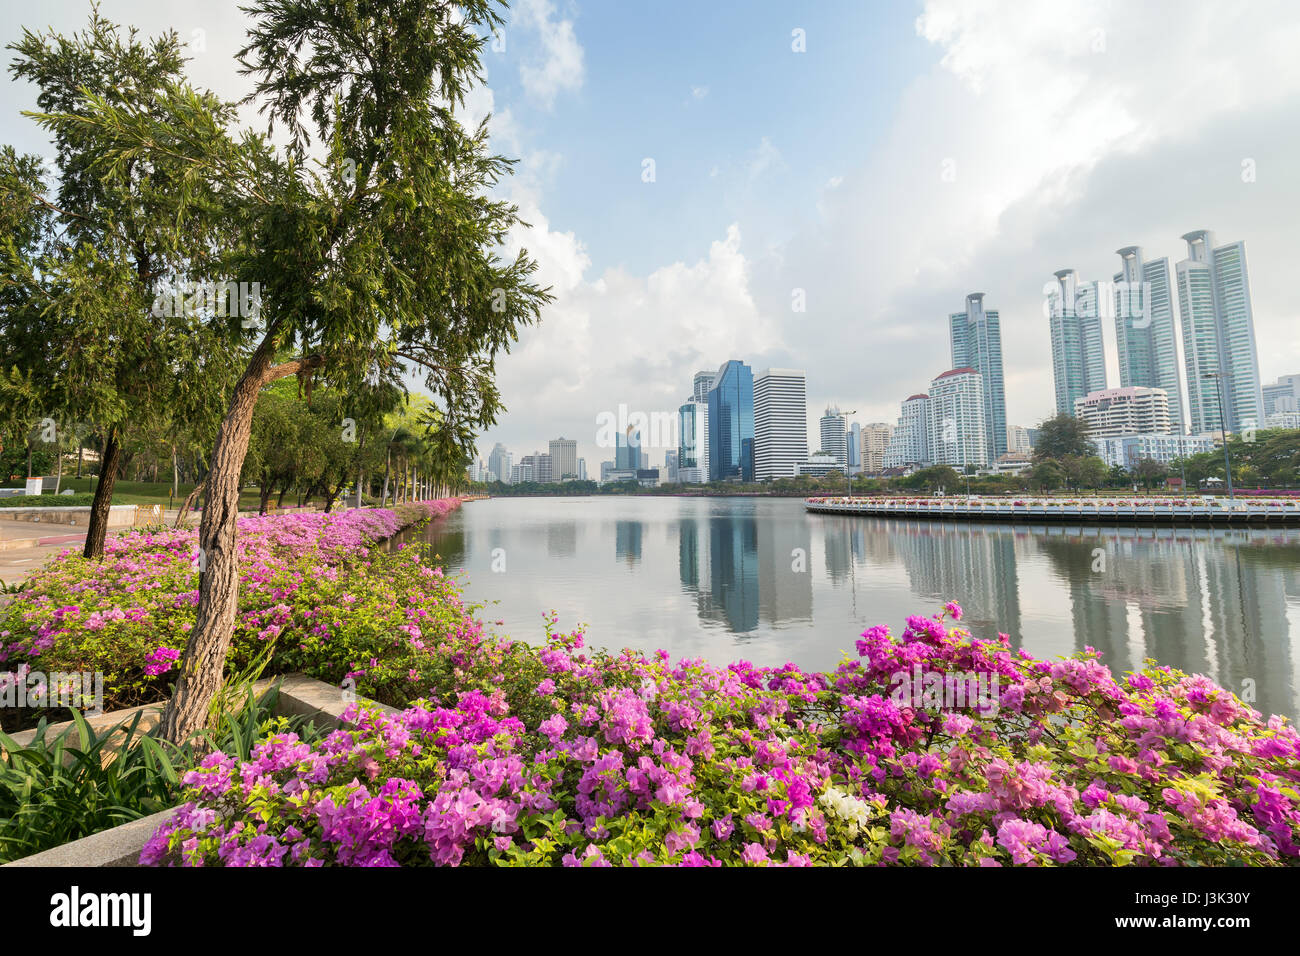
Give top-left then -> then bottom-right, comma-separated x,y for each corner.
52,0 -> 550,741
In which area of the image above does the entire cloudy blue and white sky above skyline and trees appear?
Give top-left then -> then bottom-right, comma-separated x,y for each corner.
0,0 -> 1300,475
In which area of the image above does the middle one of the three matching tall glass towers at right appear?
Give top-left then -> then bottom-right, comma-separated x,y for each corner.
1101,246 -> 1187,434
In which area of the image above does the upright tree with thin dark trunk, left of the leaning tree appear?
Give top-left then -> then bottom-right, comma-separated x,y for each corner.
5,9 -> 239,558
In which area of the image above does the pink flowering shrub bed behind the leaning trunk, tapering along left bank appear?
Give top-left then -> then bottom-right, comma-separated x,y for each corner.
0,498 -> 460,727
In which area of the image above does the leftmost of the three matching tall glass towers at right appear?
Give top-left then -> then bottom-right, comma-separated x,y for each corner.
1048,269 -> 1106,415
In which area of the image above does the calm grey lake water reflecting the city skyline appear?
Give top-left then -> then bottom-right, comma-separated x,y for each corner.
390,497 -> 1300,717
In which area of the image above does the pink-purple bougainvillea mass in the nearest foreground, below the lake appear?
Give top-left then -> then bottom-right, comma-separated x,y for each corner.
140,606 -> 1300,866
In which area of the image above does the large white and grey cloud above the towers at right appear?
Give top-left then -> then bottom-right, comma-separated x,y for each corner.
754,0 -> 1300,421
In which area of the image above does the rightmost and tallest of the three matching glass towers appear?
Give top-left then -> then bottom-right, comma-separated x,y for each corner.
1178,229 -> 1264,434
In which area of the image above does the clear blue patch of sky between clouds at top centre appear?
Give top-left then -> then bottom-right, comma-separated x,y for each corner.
486,3 -> 935,280
